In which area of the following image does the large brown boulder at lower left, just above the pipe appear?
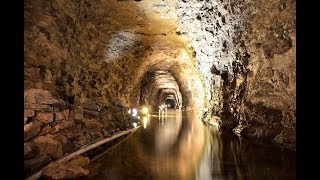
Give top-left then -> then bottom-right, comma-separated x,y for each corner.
33,136 -> 63,159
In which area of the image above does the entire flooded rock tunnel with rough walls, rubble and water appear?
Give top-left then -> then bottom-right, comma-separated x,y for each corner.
24,0 -> 296,179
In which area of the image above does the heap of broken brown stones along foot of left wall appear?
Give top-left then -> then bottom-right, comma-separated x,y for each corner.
24,89 -> 133,176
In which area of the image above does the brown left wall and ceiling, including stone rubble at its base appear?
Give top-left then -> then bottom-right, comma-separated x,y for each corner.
24,0 -> 204,174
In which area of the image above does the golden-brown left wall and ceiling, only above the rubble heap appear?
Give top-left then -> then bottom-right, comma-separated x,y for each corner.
24,0 -> 205,107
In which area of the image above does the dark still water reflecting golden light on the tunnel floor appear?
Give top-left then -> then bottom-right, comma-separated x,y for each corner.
81,111 -> 296,180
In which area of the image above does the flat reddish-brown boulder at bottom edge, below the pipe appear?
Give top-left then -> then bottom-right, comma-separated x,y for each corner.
42,162 -> 89,179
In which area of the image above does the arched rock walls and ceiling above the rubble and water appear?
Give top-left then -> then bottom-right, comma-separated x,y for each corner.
24,0 -> 296,155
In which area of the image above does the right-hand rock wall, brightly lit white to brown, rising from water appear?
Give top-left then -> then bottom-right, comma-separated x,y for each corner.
176,0 -> 296,148
